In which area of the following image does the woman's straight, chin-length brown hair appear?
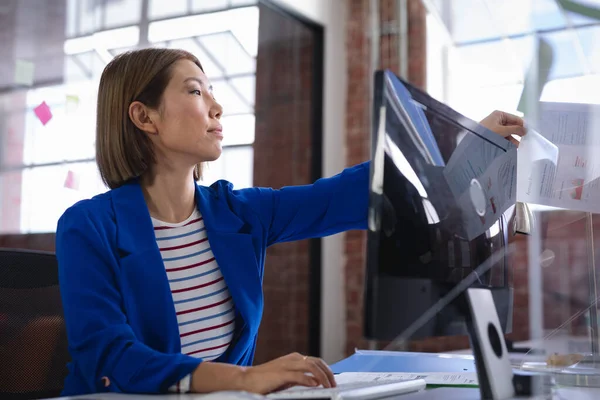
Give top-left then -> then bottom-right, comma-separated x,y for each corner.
96,48 -> 202,189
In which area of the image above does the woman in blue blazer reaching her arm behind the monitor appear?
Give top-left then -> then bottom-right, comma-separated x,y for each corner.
56,49 -> 523,395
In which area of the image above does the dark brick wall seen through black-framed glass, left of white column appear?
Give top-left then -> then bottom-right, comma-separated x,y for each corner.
254,6 -> 315,363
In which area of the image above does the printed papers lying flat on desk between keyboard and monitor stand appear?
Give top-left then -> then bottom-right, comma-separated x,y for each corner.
335,372 -> 478,387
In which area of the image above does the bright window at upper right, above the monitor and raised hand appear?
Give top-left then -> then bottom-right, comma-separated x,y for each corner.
425,0 -> 600,120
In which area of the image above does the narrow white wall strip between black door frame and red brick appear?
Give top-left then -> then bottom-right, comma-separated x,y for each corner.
274,0 -> 347,363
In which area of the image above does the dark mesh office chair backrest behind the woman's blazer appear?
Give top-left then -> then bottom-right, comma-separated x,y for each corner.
0,249 -> 70,399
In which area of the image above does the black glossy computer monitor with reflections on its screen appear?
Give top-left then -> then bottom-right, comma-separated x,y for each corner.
364,71 -> 516,340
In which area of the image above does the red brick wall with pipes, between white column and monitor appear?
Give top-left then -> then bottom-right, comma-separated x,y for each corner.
344,0 -> 426,354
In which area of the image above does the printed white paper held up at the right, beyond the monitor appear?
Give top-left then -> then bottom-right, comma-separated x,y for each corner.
517,103 -> 600,212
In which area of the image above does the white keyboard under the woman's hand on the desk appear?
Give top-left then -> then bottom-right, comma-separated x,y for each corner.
267,379 -> 426,400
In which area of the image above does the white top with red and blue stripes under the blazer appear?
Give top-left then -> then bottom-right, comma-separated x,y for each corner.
152,209 -> 235,392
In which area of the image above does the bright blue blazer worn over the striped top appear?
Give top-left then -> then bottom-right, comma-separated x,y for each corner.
56,163 -> 369,395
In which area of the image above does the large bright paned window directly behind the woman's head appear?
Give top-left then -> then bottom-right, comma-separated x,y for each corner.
0,0 -> 258,233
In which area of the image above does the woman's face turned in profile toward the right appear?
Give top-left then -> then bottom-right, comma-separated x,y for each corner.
152,60 -> 223,166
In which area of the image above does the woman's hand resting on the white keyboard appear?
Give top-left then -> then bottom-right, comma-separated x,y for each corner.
236,353 -> 336,394
